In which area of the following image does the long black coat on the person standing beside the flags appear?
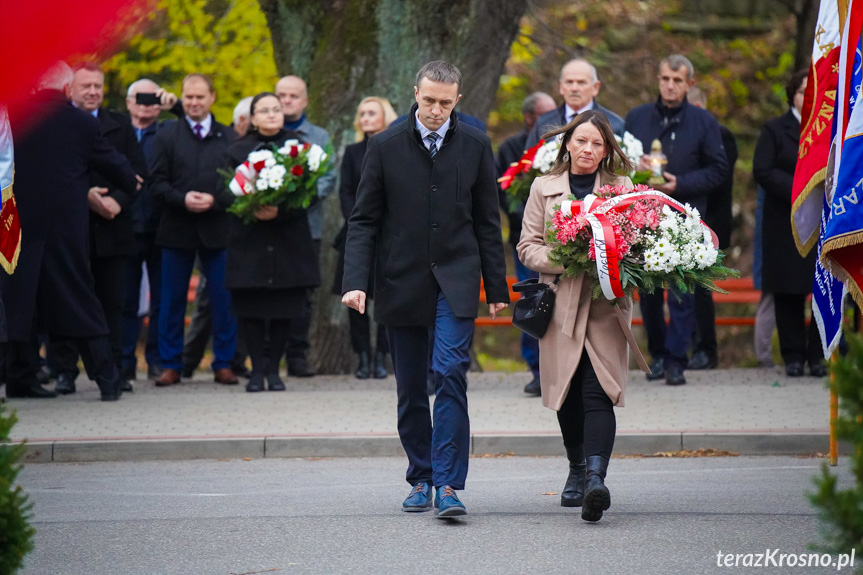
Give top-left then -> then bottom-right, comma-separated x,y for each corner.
752,110 -> 816,294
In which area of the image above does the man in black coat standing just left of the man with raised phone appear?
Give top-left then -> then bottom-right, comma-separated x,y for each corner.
48,62 -> 149,394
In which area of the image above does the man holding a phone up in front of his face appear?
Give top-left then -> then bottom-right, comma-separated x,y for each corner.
123,78 -> 183,379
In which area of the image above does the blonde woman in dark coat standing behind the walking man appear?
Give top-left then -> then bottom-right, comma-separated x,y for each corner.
333,96 -> 396,379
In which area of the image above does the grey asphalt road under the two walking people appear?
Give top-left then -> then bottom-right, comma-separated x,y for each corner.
20,457 -> 852,575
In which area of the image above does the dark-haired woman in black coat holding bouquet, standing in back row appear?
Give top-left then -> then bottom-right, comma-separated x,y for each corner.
225,92 -> 321,391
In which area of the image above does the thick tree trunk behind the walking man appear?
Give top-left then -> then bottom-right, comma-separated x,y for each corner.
259,0 -> 528,373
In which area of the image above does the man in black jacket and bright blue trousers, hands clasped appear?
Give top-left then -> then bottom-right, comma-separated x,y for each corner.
150,74 -> 237,386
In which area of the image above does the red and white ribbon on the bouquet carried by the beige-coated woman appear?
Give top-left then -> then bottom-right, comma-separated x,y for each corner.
560,190 -> 719,299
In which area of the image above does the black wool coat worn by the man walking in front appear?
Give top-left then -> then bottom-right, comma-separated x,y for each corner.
342,104 -> 509,326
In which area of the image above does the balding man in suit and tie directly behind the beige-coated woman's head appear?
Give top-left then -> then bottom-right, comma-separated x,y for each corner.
525,58 -> 624,148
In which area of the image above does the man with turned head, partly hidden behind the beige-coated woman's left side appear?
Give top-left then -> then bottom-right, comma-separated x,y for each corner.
497,92 -> 555,396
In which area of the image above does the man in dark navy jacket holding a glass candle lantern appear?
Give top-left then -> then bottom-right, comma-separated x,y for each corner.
626,54 -> 728,385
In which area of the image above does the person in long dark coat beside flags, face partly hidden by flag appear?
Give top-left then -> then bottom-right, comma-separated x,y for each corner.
752,70 -> 827,377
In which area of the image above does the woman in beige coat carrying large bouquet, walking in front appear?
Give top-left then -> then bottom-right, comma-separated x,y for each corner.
516,110 -> 632,521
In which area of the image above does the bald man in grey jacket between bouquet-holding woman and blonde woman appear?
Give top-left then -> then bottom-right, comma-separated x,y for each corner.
276,76 -> 336,377
